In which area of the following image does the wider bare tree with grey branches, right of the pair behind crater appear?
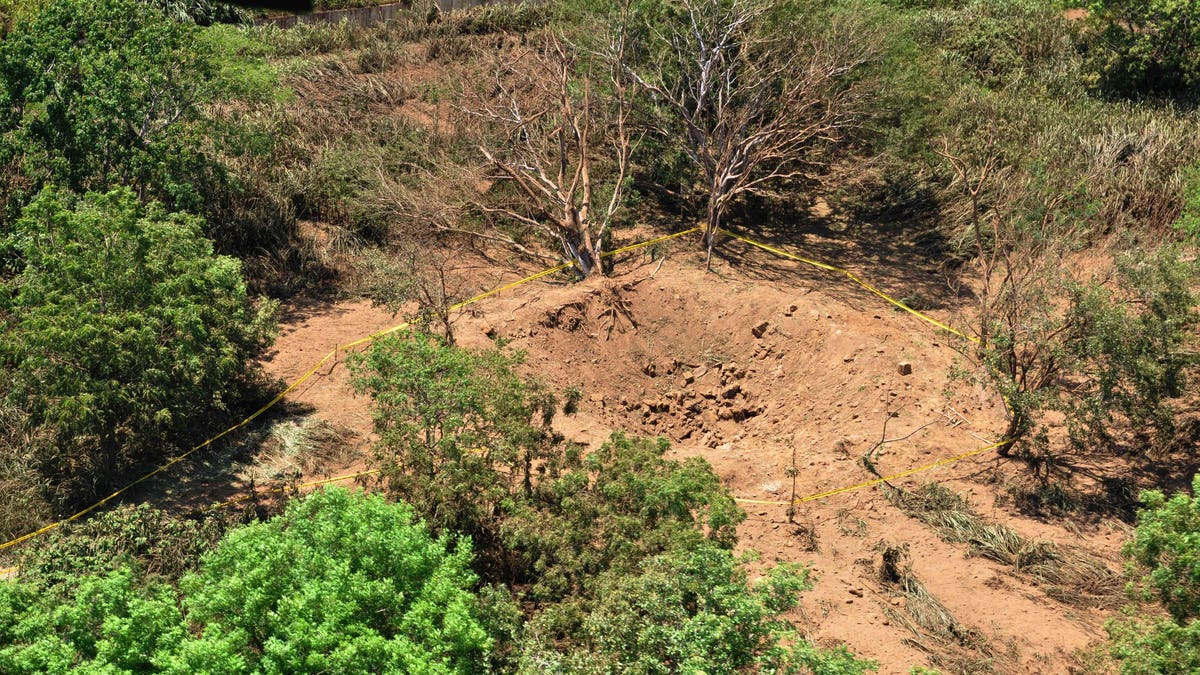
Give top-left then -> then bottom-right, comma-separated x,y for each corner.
625,0 -> 878,266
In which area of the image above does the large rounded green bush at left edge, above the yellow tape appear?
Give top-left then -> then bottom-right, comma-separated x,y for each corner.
0,190 -> 275,503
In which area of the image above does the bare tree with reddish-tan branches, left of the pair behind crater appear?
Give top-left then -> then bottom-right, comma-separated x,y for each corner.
468,32 -> 635,276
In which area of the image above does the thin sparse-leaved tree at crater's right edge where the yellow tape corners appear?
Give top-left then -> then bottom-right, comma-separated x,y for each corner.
935,130 -> 1094,455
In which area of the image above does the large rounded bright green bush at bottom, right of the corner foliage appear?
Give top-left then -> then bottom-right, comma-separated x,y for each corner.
175,489 -> 491,674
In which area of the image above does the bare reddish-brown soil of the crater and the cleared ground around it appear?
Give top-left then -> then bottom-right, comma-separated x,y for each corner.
255,234 -> 1123,673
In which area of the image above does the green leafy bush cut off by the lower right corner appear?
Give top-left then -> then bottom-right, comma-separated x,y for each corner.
1108,476 -> 1200,675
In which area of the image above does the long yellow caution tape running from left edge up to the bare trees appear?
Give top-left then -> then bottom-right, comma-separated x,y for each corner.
0,227 -> 700,551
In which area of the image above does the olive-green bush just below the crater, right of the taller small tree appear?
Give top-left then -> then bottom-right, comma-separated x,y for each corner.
503,431 -> 745,611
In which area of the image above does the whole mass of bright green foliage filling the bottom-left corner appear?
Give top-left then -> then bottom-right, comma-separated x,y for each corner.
0,489 -> 491,674
